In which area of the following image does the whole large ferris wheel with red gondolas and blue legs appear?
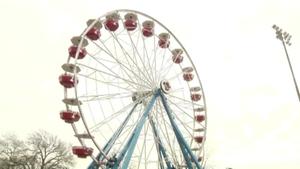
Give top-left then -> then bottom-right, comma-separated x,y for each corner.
59,9 -> 207,169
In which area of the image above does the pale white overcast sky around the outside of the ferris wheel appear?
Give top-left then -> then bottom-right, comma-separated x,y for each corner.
0,0 -> 300,169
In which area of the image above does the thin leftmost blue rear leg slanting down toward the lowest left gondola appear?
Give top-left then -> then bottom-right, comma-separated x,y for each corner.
88,103 -> 138,169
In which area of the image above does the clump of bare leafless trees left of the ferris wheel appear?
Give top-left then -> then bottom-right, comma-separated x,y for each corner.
0,131 -> 74,169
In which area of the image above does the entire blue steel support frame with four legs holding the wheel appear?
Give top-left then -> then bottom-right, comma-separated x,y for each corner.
88,89 -> 203,169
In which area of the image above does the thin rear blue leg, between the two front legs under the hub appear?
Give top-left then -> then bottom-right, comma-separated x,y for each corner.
148,117 -> 172,169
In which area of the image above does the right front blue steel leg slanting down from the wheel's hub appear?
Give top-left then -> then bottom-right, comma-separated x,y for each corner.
159,91 -> 202,169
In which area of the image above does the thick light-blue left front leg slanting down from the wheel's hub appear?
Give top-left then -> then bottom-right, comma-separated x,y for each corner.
113,90 -> 159,169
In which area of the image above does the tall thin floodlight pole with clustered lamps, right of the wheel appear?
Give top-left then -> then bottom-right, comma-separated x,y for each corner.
272,25 -> 300,102
